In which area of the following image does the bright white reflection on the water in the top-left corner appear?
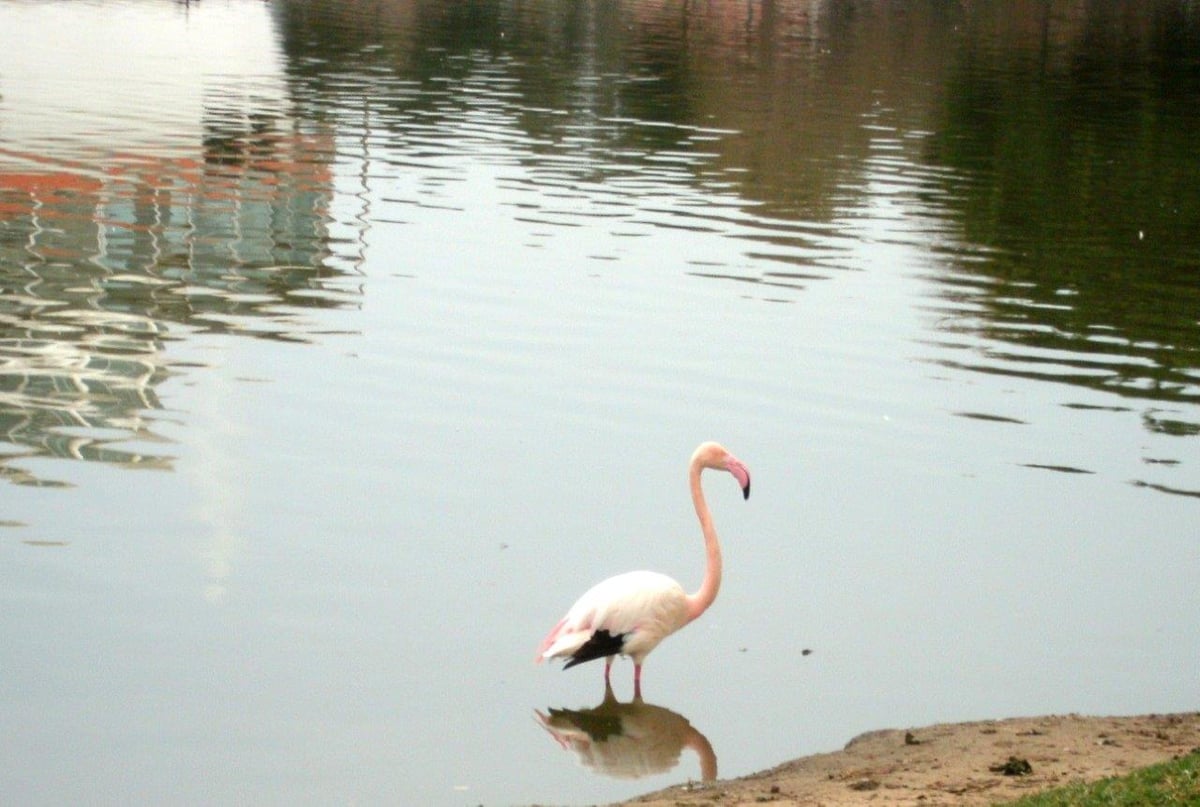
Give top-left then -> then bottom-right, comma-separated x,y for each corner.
0,2 -> 282,159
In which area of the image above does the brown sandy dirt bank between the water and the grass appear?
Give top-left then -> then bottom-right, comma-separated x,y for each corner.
622,712 -> 1200,807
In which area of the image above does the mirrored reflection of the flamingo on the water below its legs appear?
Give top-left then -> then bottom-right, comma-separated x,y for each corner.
535,685 -> 716,782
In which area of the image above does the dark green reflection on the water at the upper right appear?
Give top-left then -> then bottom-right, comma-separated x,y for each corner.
926,2 -> 1200,404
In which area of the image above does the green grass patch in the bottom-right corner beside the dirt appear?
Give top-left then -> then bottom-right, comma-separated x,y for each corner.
1004,748 -> 1200,807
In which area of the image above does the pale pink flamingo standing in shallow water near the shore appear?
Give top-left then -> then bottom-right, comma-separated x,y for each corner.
535,442 -> 750,699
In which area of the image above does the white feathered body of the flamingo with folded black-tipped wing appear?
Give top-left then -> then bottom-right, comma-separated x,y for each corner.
536,572 -> 688,666
